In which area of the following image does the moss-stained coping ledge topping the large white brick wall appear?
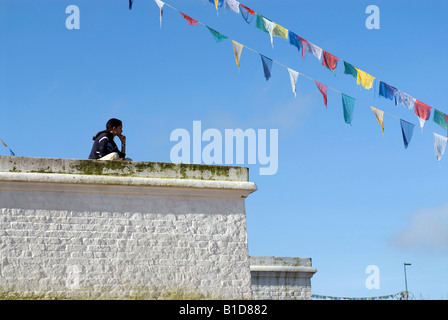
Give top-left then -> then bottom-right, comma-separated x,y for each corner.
0,156 -> 257,197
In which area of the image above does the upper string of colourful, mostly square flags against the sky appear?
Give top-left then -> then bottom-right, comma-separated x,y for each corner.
204,0 -> 448,132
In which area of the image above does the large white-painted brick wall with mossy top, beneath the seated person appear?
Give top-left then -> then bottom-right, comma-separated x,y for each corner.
0,157 -> 256,299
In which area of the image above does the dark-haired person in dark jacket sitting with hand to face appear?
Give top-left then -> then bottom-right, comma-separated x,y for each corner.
89,118 -> 129,160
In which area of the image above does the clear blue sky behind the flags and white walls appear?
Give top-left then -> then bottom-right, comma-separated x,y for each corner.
0,0 -> 448,299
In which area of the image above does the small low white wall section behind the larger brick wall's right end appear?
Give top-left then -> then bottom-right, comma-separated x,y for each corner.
250,257 -> 316,300
